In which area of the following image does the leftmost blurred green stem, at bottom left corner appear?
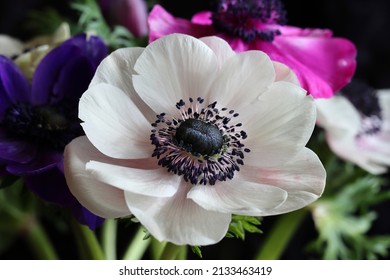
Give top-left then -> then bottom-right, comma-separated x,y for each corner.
22,216 -> 58,260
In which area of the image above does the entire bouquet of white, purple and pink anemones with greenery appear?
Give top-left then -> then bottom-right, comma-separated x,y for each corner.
0,0 -> 390,259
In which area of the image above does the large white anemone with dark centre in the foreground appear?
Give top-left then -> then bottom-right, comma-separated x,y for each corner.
65,34 -> 325,245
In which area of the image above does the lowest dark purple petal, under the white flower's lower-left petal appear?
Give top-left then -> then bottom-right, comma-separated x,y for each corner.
25,167 -> 104,229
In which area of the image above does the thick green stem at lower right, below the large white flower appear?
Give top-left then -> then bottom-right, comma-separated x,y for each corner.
256,208 -> 308,260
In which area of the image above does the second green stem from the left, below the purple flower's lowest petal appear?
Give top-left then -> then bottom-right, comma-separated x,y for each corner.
71,219 -> 104,260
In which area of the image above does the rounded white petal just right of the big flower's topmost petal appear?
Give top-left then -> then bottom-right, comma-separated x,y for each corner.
210,51 -> 275,110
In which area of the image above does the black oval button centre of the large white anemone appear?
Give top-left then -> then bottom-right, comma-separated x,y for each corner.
175,119 -> 223,156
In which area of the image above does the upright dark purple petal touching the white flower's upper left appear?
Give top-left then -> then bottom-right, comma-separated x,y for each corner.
31,34 -> 108,105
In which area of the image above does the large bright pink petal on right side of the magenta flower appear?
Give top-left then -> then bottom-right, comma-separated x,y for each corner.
257,28 -> 356,98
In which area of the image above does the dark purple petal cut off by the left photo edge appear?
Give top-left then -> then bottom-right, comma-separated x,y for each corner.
0,55 -> 30,116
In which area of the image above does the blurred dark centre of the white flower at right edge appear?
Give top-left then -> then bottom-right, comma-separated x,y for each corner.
342,80 -> 382,134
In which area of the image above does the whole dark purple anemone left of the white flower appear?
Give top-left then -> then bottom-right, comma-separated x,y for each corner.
0,34 -> 107,228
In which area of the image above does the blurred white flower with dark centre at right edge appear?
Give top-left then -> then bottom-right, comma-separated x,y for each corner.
315,83 -> 390,174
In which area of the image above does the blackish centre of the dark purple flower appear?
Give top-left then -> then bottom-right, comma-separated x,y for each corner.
1,103 -> 83,150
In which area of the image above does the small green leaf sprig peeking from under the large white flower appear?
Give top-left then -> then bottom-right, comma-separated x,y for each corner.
226,215 -> 262,240
